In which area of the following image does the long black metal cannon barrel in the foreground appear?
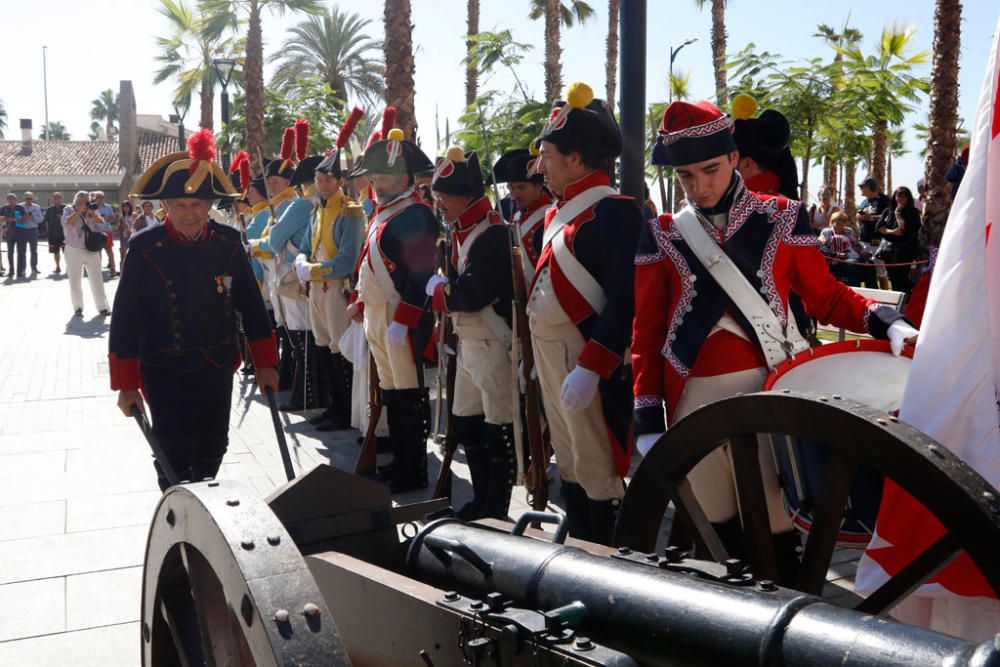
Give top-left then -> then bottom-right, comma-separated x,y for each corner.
406,519 -> 1000,667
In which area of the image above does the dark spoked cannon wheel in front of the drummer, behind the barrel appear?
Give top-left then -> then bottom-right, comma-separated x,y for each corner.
614,391 -> 1000,614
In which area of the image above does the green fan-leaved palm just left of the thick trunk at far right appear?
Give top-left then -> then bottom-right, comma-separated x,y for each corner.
844,25 -> 929,193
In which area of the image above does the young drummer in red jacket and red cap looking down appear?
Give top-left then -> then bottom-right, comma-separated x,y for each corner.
632,102 -> 916,572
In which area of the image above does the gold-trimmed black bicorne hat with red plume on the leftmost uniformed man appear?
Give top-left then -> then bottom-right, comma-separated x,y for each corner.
129,128 -> 238,200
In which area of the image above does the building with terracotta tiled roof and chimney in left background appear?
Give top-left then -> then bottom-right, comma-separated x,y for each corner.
0,81 -> 178,207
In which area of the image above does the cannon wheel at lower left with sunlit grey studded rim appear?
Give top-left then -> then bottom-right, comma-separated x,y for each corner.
141,480 -> 350,667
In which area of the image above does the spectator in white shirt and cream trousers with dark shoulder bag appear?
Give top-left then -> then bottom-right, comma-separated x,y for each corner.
62,190 -> 111,317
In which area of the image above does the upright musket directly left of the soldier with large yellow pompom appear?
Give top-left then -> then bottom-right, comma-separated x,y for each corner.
476,101 -> 549,510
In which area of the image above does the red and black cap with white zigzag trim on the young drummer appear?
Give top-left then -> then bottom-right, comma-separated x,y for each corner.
651,100 -> 736,167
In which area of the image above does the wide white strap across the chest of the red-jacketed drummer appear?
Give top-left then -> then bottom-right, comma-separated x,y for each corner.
668,206 -> 809,369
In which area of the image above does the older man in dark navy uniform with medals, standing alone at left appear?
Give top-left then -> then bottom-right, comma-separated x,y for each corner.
109,130 -> 278,489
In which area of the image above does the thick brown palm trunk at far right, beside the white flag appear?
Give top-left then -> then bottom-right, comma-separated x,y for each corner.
924,0 -> 962,207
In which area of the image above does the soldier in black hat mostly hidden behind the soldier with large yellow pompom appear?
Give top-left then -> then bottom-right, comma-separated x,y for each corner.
493,148 -> 552,282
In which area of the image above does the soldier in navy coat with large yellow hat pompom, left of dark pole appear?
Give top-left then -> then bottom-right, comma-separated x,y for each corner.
527,83 -> 642,544
